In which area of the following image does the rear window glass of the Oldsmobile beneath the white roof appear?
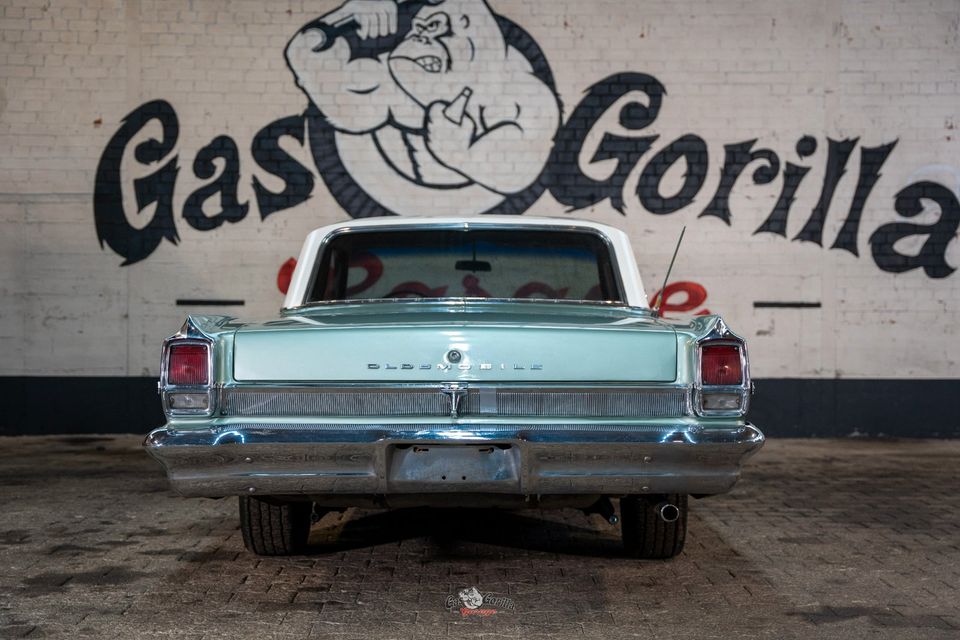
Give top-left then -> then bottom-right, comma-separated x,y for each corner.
306,229 -> 623,303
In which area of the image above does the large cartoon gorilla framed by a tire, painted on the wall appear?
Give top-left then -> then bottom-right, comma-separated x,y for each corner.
286,0 -> 561,217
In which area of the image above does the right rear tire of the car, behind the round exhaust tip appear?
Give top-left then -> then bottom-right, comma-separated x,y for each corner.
620,493 -> 687,559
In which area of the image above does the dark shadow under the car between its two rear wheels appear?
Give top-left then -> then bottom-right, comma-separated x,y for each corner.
308,508 -> 623,557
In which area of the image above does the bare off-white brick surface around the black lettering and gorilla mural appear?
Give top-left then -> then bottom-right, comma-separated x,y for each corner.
0,0 -> 960,378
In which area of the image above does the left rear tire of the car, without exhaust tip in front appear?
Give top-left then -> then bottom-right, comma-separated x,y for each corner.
240,496 -> 313,556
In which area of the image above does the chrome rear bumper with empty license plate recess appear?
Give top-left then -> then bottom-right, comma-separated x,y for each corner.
144,422 -> 764,497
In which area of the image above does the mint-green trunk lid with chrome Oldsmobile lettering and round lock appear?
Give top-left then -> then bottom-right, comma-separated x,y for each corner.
233,300 -> 677,384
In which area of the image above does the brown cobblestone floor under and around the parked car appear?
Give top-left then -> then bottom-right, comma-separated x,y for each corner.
0,436 -> 960,640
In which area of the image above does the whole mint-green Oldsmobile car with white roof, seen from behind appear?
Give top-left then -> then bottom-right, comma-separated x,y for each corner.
144,216 -> 763,558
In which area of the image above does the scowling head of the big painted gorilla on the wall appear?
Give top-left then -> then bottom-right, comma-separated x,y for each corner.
388,0 -> 506,107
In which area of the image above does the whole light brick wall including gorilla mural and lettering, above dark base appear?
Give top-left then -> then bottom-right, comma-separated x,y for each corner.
0,0 -> 960,379
